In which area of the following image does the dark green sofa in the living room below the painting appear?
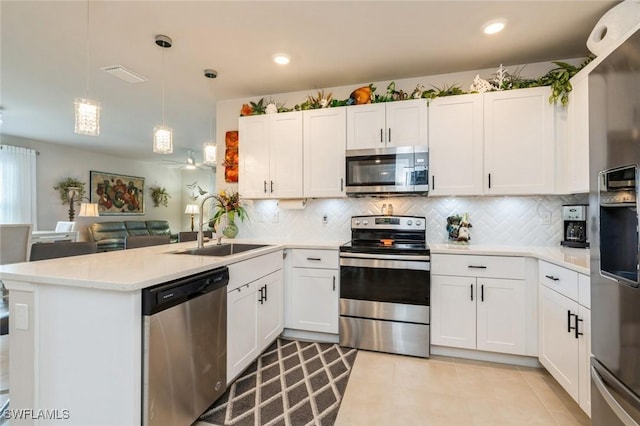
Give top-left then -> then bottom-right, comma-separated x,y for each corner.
89,220 -> 178,252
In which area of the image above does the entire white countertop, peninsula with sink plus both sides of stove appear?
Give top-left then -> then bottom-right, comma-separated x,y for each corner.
0,239 -> 589,291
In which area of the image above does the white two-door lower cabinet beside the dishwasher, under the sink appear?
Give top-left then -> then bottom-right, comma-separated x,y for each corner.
227,251 -> 284,384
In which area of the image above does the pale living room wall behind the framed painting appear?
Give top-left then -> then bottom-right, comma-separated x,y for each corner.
2,135 -> 215,240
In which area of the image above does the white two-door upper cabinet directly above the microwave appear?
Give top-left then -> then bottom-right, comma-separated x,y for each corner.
347,99 -> 429,149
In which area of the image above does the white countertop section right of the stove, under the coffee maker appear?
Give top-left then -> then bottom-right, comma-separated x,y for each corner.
429,243 -> 590,275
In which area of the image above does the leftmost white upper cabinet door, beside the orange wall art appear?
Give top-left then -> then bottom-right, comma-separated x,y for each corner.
238,115 -> 269,198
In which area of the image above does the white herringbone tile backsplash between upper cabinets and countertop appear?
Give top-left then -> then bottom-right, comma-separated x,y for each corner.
239,195 -> 586,246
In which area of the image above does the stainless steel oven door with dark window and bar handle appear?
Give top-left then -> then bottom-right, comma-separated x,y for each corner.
340,253 -> 431,324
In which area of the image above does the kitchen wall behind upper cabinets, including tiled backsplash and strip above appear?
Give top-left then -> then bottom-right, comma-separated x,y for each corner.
216,59 -> 586,246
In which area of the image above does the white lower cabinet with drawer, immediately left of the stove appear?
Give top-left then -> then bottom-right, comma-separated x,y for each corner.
285,249 -> 340,334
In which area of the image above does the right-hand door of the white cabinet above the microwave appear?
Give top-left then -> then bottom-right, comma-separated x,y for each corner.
385,99 -> 429,146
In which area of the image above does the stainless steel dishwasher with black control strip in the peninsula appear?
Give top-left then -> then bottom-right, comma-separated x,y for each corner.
142,266 -> 229,426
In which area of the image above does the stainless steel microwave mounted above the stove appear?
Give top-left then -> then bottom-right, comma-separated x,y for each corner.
346,146 -> 429,197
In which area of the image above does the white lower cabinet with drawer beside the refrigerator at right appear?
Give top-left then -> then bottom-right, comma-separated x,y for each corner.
538,261 -> 591,415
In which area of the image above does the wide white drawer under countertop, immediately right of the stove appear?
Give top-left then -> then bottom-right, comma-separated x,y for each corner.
431,254 -> 525,279
